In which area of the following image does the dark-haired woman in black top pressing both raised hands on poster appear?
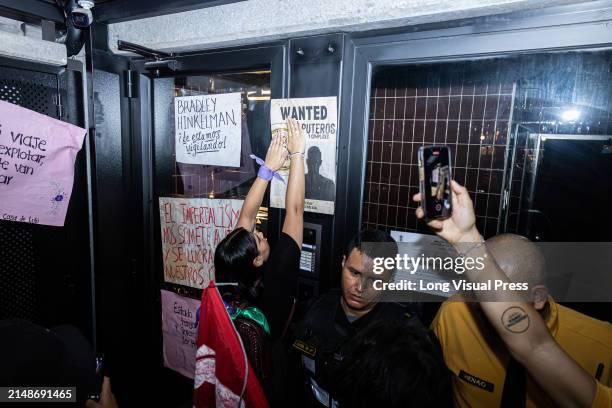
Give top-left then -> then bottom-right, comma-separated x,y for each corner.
215,119 -> 305,338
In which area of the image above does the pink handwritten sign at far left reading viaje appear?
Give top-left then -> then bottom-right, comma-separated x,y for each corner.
0,101 -> 85,226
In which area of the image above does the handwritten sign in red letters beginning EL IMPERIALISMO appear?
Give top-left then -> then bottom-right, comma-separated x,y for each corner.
159,197 -> 243,289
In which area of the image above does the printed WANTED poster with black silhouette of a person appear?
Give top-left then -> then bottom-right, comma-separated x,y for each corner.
270,96 -> 338,214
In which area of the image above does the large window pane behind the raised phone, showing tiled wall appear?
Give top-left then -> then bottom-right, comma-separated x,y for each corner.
362,51 -> 612,241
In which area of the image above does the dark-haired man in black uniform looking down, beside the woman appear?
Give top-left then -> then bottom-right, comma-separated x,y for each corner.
292,230 -> 443,408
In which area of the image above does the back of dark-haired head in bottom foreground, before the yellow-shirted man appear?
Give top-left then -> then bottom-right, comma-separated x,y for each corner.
335,320 -> 452,408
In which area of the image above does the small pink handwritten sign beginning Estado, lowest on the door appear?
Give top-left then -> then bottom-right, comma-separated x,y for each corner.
161,290 -> 200,378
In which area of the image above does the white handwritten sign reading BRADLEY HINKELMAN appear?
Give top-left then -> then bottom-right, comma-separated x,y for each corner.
174,92 -> 242,167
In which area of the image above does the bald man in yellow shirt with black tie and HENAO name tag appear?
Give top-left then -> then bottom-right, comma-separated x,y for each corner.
431,234 -> 612,407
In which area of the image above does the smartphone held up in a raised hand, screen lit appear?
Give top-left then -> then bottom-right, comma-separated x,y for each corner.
418,146 -> 453,220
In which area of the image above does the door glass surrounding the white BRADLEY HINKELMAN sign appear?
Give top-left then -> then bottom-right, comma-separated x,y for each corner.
153,69 -> 271,207
